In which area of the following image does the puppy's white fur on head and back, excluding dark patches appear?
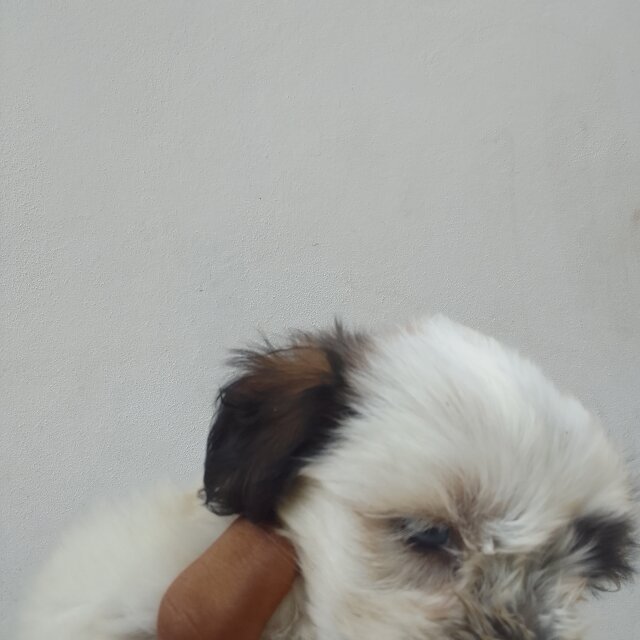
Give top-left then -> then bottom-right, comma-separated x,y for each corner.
21,317 -> 633,640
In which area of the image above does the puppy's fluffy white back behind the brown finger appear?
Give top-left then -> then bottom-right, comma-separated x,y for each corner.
21,487 -> 231,640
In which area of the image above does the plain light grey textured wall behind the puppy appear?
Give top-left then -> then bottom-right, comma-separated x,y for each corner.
0,0 -> 640,640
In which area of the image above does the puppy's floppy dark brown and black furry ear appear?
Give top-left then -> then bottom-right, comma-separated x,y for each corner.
204,326 -> 362,522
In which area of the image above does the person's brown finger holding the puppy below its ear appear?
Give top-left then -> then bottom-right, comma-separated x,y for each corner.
157,518 -> 297,640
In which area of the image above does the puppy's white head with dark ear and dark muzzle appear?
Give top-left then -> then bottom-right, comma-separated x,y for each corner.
205,318 -> 633,640
